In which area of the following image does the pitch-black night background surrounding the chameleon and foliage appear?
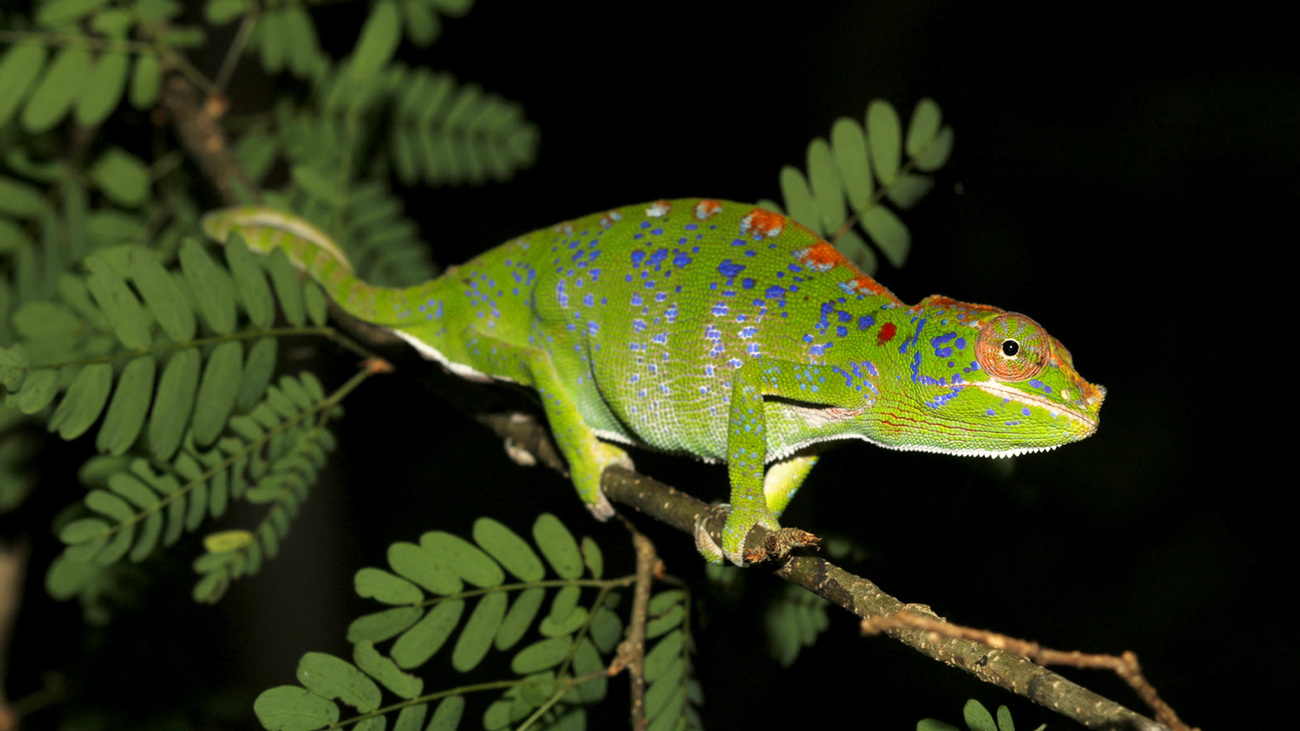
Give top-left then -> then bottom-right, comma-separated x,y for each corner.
12,1 -> 1300,730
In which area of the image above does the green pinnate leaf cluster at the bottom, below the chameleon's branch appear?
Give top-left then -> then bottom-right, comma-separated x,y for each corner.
255,514 -> 665,731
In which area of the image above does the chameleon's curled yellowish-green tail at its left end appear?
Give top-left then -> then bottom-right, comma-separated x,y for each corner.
202,206 -> 400,324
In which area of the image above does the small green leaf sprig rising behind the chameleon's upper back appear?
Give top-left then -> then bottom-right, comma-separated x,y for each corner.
761,99 -> 953,274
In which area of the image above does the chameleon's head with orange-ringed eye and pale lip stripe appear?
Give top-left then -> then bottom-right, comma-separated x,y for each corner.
879,298 -> 1106,457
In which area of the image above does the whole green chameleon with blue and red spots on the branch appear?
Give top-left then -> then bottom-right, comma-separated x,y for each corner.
203,198 -> 1106,565
